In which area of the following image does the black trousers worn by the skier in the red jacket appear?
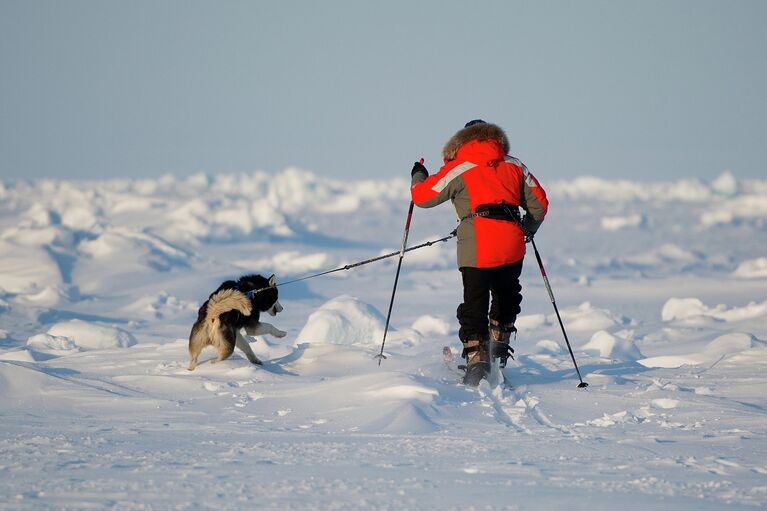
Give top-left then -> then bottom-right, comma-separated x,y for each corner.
457,259 -> 523,341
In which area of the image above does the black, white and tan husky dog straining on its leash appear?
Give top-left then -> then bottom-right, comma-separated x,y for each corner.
188,275 -> 286,371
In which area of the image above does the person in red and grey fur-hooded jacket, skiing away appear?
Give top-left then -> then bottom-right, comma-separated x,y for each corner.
410,119 -> 548,386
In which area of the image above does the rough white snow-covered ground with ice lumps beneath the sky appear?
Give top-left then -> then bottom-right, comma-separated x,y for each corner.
0,169 -> 767,510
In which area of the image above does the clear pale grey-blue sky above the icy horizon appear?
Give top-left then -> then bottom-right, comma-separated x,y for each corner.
0,0 -> 767,182
